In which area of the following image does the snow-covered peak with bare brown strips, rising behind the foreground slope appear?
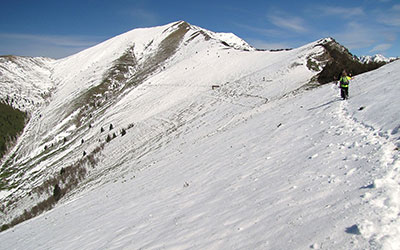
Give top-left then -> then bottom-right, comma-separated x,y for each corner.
0,21 -> 324,223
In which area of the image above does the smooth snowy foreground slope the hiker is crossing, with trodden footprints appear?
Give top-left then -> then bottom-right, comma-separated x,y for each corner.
0,60 -> 400,249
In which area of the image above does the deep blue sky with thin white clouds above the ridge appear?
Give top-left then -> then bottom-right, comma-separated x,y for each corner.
0,0 -> 400,58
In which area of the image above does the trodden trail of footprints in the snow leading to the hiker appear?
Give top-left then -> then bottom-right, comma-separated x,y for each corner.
337,87 -> 400,250
